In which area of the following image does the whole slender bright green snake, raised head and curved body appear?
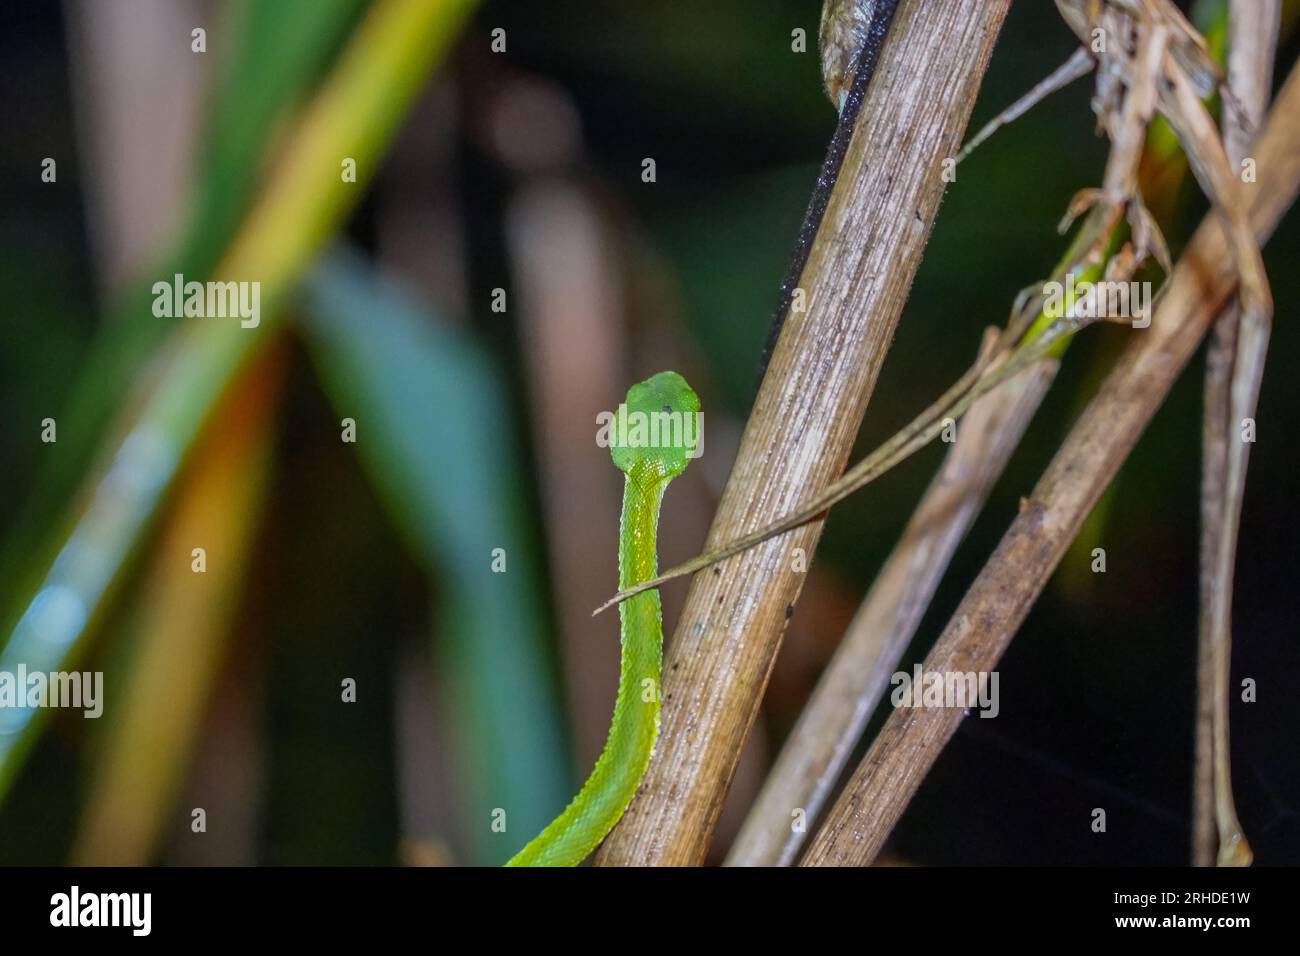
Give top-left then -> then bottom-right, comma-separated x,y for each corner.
506,372 -> 699,866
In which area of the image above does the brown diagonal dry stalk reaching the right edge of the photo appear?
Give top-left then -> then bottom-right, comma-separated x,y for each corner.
802,57 -> 1300,866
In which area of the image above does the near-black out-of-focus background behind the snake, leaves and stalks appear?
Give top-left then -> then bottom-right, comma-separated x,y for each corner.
0,0 -> 1300,865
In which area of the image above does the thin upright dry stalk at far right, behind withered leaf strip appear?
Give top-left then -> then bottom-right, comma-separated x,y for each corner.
1192,0 -> 1282,866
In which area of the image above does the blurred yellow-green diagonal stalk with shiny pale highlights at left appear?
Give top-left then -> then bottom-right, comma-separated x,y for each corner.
0,0 -> 475,797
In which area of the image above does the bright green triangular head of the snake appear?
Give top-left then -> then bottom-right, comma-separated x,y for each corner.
610,372 -> 703,479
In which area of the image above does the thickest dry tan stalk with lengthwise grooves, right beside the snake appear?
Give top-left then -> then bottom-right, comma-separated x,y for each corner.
597,0 -> 1009,865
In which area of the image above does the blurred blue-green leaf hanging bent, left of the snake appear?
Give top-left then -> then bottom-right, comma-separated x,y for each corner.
303,252 -> 571,862
